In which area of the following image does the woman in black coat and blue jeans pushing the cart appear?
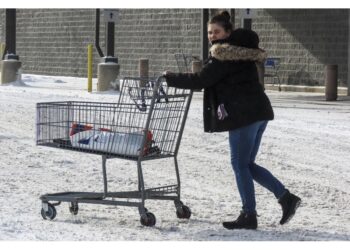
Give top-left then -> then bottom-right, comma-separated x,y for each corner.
163,11 -> 301,229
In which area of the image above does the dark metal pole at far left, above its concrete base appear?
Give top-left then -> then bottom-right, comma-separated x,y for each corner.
5,9 -> 16,54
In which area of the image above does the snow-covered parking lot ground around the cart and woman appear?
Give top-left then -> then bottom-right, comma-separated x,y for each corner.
0,75 -> 350,241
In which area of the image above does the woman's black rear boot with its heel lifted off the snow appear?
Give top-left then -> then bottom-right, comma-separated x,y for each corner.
278,190 -> 301,225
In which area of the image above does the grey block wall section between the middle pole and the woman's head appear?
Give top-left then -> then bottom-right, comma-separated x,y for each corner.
115,9 -> 201,76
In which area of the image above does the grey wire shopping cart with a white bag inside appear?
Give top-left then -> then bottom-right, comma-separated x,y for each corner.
36,77 -> 192,226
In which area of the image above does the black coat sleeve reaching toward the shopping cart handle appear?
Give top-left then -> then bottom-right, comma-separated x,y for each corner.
165,58 -> 227,89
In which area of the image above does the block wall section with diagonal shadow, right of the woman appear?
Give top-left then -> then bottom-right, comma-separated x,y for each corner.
253,9 -> 349,86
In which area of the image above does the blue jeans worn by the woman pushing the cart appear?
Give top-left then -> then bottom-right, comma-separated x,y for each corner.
229,121 -> 286,213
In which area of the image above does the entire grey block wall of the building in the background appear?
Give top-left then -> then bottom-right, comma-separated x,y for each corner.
0,9 -> 349,86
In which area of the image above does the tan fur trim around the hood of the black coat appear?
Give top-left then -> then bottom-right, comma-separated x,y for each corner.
210,43 -> 267,62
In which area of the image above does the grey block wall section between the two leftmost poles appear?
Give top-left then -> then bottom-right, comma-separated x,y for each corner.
16,9 -> 102,76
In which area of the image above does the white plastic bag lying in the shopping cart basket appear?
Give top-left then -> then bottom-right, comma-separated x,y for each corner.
70,129 -> 148,156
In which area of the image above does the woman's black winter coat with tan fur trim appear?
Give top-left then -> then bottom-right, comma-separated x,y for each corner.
165,43 -> 274,132
